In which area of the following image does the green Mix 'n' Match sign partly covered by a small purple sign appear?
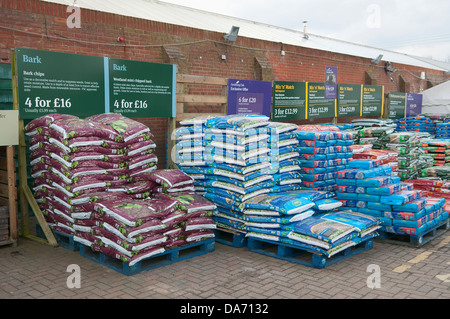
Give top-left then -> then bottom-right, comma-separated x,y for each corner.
308,82 -> 336,119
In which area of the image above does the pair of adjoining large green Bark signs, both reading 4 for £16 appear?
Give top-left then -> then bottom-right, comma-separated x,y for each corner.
15,48 -> 176,119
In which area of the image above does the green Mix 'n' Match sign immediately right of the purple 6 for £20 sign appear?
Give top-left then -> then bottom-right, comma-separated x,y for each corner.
272,81 -> 307,121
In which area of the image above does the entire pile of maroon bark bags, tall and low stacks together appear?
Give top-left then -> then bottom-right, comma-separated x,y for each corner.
25,114 -> 215,265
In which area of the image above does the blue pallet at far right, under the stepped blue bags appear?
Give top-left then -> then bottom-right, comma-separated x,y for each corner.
378,218 -> 450,247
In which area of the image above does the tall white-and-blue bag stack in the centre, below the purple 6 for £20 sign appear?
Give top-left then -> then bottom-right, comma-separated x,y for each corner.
175,115 -> 274,232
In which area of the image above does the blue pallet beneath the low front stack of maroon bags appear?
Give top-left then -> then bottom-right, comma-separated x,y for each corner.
80,238 -> 215,276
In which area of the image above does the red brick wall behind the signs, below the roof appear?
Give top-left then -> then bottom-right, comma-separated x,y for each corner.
0,0 -> 445,167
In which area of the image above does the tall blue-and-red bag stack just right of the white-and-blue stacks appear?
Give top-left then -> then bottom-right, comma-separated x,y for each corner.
296,125 -> 353,192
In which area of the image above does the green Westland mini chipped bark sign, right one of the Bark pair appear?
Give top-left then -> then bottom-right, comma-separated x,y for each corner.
107,59 -> 176,117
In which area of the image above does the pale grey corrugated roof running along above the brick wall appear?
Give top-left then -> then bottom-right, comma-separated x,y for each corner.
41,0 -> 450,71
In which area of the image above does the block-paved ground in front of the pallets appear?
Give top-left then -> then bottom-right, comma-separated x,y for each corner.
0,231 -> 450,300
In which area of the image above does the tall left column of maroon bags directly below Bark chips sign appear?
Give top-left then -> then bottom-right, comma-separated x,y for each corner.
25,114 -> 138,239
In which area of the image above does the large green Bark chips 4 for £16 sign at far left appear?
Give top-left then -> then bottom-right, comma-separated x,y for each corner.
16,48 -> 105,119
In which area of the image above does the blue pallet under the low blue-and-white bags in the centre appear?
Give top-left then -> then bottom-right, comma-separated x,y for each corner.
247,237 -> 373,269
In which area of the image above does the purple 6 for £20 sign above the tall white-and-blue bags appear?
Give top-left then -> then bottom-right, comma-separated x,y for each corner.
227,79 -> 272,117
